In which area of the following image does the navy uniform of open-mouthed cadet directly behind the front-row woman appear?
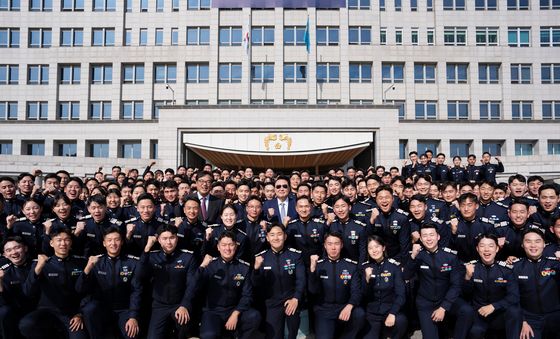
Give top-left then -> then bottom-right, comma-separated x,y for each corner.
370,208 -> 410,261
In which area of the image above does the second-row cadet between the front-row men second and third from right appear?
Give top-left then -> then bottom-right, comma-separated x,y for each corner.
449,193 -> 495,263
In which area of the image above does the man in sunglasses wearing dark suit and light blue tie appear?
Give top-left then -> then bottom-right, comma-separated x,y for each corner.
263,176 -> 297,225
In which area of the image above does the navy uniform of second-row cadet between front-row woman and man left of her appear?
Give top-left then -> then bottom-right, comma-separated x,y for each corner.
329,219 -> 368,262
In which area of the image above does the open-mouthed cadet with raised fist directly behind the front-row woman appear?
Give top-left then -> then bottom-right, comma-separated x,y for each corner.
368,185 -> 410,261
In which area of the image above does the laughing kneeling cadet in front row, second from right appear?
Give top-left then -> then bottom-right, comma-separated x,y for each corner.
463,234 -> 521,339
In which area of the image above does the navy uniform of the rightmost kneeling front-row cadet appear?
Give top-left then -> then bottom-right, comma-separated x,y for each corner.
513,257 -> 560,339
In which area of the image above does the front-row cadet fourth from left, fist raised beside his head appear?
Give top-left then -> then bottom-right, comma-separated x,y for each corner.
141,224 -> 198,338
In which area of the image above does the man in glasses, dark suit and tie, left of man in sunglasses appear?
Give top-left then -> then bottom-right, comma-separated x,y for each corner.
191,171 -> 224,225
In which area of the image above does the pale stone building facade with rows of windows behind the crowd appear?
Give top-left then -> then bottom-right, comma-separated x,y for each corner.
0,0 -> 560,176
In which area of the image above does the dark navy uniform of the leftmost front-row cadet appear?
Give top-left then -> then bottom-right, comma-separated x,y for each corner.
0,261 -> 36,338
